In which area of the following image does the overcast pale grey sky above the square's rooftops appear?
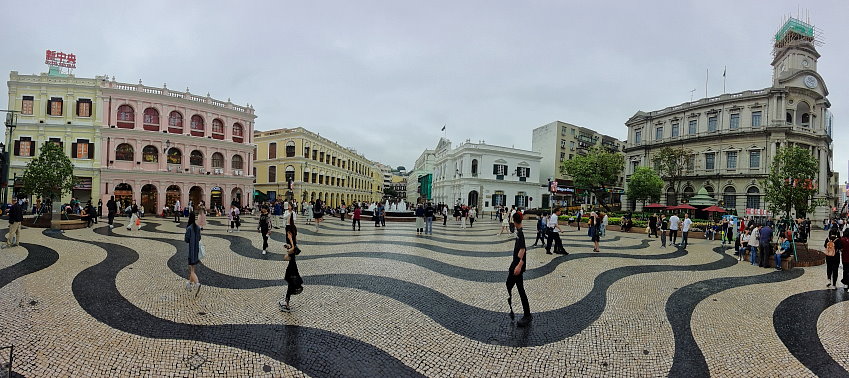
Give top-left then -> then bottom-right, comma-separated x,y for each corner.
0,0 -> 849,177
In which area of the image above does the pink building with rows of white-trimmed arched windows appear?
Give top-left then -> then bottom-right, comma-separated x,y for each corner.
98,78 -> 256,214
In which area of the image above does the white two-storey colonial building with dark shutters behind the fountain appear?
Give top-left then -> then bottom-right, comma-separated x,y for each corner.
433,138 -> 545,211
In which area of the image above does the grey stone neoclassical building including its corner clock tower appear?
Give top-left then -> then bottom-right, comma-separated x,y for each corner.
623,18 -> 838,219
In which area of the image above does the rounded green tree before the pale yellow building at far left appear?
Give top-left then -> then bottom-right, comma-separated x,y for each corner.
21,142 -> 77,213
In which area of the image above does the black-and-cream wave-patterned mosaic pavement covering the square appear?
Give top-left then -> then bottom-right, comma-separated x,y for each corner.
0,214 -> 849,377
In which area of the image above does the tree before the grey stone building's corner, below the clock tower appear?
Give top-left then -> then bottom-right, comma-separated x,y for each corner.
761,146 -> 824,219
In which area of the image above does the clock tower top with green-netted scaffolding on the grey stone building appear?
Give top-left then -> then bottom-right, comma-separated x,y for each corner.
772,17 -> 820,89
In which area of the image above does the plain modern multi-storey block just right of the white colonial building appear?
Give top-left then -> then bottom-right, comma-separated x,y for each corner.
531,121 -> 625,207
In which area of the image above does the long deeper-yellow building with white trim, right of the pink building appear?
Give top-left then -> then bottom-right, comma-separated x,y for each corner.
254,127 -> 383,206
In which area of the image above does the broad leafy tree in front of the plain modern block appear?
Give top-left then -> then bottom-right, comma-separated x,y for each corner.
560,146 -> 625,211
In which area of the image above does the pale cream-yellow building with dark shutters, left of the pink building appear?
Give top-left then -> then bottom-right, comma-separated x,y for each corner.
6,71 -> 105,205
